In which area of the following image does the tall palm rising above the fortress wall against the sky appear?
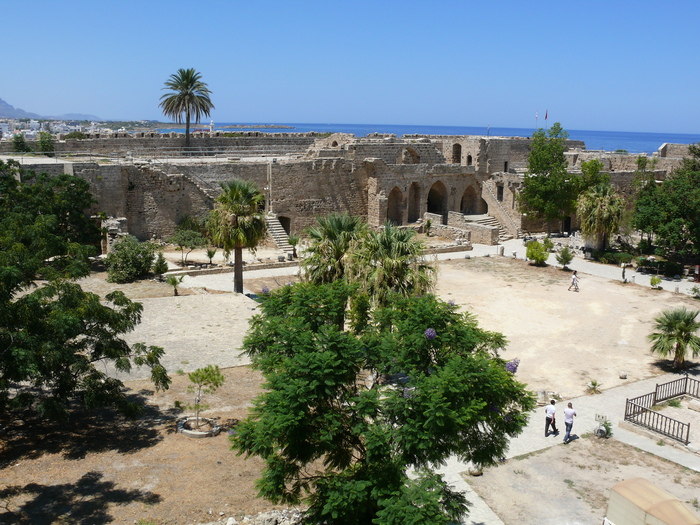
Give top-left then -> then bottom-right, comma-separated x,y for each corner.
159,68 -> 214,148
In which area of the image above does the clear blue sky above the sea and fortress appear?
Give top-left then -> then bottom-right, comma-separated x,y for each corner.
0,0 -> 700,133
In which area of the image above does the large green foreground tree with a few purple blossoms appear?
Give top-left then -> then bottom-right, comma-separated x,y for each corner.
232,280 -> 534,524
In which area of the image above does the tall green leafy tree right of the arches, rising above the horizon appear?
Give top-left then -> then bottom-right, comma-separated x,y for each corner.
518,122 -> 580,233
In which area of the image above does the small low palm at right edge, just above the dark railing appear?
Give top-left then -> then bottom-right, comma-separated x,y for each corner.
647,307 -> 700,368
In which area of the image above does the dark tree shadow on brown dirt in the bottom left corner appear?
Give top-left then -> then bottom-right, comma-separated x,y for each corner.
0,472 -> 162,525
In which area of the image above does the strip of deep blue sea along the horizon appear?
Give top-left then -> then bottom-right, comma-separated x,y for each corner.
158,122 -> 700,154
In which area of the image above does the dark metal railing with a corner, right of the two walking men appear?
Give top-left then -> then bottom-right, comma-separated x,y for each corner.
625,374 -> 700,445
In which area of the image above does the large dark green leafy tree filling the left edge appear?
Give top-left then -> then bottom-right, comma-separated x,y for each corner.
0,161 -> 170,417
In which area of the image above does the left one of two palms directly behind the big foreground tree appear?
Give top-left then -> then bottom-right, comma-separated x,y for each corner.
302,213 -> 367,284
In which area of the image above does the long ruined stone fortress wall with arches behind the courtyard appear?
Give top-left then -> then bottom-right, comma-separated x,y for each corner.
8,132 -> 688,244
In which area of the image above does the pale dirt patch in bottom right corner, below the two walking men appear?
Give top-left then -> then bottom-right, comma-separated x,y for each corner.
465,436 -> 700,525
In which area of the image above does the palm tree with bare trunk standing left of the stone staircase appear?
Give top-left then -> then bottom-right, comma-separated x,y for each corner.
207,179 -> 267,293
